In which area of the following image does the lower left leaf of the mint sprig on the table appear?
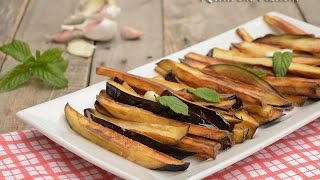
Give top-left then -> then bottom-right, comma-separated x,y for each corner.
0,64 -> 32,92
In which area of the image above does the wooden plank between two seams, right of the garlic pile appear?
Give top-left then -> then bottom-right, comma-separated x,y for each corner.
90,0 -> 163,84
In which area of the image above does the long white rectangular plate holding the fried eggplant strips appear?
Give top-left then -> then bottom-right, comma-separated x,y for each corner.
17,13 -> 320,179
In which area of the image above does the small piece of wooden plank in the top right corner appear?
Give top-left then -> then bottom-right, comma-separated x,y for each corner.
298,0 -> 320,26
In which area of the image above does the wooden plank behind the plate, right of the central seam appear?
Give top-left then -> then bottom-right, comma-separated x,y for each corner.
163,0 -> 302,55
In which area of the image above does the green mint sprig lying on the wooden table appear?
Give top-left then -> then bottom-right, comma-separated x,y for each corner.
0,40 -> 68,92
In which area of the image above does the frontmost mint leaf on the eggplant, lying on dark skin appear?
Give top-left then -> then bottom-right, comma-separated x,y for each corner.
155,96 -> 189,116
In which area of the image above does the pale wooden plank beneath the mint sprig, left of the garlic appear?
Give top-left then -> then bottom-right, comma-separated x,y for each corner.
0,0 -> 91,133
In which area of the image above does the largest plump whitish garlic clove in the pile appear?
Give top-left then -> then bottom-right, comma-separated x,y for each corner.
82,19 -> 117,41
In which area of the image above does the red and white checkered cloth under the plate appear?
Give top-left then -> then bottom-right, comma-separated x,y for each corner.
0,118 -> 320,180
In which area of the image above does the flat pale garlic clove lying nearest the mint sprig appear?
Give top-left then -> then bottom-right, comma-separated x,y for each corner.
67,39 -> 95,58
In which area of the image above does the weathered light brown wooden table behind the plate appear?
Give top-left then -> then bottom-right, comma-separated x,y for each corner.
0,0 -> 320,133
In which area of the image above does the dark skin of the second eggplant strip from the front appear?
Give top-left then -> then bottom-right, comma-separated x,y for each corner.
84,109 -> 195,160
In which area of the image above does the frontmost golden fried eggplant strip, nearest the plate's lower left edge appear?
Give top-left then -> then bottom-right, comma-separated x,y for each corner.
64,104 -> 190,171
